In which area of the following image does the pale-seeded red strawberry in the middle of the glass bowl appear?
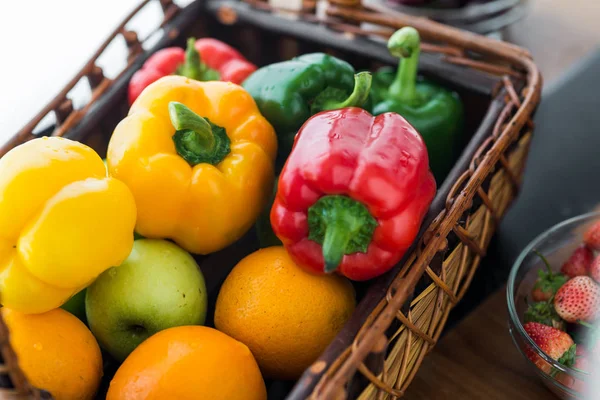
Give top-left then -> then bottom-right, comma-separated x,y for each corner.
554,276 -> 600,322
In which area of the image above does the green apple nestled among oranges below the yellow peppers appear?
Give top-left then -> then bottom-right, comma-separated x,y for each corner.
85,239 -> 207,361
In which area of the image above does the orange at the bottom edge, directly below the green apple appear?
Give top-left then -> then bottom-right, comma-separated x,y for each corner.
106,326 -> 267,400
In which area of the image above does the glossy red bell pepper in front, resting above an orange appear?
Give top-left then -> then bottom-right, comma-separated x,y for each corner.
271,108 -> 436,281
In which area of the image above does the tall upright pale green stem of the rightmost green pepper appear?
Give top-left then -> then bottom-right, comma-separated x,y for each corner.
388,26 -> 421,103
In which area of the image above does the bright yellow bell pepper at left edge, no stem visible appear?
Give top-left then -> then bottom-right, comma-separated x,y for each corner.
0,137 -> 136,313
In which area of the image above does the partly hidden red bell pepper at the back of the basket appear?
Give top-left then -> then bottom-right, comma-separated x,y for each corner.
129,38 -> 256,105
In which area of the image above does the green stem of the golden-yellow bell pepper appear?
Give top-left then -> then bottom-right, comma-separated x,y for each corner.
169,101 -> 231,166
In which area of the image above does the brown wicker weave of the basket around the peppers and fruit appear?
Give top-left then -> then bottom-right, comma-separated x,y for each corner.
0,0 -> 541,400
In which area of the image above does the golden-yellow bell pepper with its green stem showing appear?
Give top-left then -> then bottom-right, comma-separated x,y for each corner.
107,76 -> 277,254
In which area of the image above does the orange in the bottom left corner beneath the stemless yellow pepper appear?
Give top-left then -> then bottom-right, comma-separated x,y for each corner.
2,308 -> 102,400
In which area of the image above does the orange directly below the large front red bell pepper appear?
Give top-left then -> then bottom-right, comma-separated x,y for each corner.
215,247 -> 356,379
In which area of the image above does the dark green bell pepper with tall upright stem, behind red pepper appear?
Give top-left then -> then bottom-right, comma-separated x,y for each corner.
371,27 -> 464,180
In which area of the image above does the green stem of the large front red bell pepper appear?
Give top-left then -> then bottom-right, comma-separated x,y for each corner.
308,195 -> 377,273
